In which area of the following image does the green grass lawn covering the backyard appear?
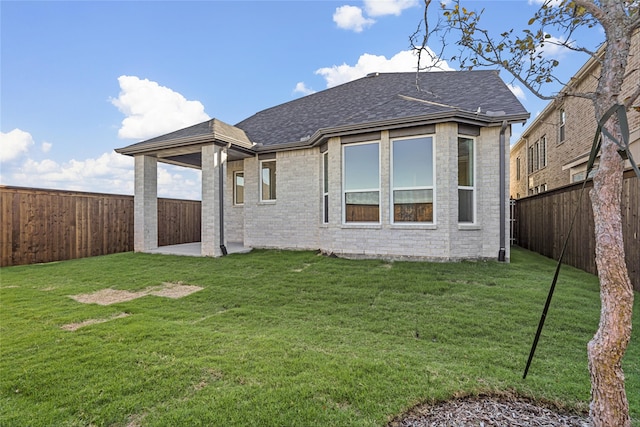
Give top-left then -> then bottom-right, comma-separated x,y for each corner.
0,249 -> 640,426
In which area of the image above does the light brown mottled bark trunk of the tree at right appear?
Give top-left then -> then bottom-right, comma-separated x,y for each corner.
588,133 -> 633,427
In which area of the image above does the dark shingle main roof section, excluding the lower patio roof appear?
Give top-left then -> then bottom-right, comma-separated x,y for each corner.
236,70 -> 528,146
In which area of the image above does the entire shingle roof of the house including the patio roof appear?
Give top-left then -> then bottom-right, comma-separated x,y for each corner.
116,70 -> 529,154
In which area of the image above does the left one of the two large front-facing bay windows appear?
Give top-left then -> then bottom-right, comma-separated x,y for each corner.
342,142 -> 380,222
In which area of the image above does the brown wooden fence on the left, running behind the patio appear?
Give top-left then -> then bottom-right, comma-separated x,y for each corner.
0,186 -> 201,267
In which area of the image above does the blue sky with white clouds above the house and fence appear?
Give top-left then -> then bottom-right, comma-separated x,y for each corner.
0,0 -> 603,199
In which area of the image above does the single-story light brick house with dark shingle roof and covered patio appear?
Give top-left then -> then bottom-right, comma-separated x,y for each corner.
116,71 -> 529,260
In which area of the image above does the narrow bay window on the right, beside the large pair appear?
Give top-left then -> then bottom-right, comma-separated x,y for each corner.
458,137 -> 475,222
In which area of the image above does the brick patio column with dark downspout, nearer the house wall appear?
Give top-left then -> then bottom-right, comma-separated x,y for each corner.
201,144 -> 226,257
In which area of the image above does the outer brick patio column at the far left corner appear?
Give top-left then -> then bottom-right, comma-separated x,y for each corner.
133,155 -> 158,252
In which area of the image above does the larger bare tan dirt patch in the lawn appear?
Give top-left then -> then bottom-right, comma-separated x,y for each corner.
71,282 -> 202,305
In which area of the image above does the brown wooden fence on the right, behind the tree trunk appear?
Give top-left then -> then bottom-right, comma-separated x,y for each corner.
512,171 -> 640,291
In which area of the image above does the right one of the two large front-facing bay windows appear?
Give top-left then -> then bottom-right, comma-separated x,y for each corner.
391,136 -> 434,223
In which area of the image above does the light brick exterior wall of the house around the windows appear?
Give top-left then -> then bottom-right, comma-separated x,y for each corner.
230,123 -> 510,261
